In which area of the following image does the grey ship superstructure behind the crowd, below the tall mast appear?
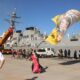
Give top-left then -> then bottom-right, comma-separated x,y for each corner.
5,27 -> 47,48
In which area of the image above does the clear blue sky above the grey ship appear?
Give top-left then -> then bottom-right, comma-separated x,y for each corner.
0,0 -> 80,35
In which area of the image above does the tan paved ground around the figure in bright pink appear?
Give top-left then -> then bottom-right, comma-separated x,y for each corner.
0,55 -> 80,80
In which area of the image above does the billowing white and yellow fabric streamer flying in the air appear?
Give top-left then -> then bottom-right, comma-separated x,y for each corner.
46,9 -> 80,45
